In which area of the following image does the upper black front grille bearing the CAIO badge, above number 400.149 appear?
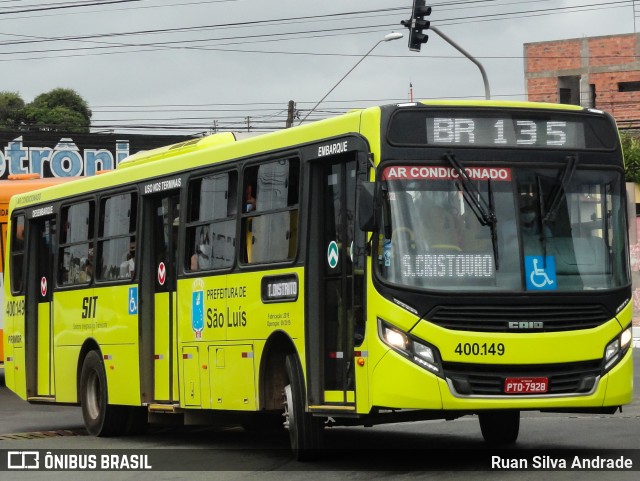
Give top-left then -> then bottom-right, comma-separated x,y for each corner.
426,304 -> 611,333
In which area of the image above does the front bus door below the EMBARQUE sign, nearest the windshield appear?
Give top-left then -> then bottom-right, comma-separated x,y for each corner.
306,147 -> 366,408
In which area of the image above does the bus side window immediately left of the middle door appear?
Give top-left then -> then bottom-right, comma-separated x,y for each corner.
97,193 -> 137,281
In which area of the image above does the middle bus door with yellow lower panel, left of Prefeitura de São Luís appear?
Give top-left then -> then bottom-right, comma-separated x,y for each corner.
140,190 -> 180,403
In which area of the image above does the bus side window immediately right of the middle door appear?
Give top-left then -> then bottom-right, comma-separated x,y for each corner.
186,172 -> 238,271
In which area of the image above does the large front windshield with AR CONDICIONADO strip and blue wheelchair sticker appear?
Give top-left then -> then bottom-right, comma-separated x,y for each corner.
377,163 -> 629,291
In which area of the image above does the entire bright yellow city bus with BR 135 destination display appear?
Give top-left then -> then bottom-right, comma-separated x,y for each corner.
5,101 -> 632,458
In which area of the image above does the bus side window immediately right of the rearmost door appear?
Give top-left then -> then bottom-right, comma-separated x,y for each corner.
58,202 -> 94,286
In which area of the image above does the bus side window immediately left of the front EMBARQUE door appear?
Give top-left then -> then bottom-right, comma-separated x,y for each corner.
242,159 -> 300,264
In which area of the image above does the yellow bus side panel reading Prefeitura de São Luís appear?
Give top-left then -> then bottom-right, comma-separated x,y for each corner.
177,268 -> 305,410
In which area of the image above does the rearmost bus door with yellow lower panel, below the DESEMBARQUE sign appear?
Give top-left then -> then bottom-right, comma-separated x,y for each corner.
25,217 -> 56,397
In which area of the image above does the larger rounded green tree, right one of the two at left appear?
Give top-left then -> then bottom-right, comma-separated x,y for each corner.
24,88 -> 91,133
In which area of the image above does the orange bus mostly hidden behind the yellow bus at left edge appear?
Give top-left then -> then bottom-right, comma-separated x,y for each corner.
0,174 -> 69,367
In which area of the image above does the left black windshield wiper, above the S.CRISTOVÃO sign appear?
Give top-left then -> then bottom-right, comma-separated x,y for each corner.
444,152 -> 499,270
